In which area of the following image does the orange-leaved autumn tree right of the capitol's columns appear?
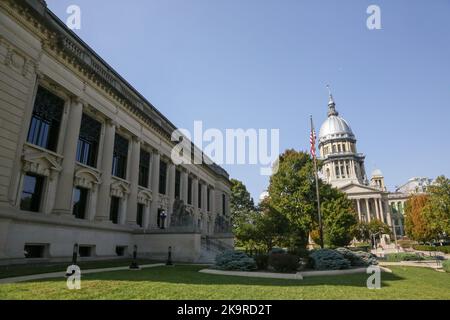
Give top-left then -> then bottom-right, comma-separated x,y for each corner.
405,194 -> 434,242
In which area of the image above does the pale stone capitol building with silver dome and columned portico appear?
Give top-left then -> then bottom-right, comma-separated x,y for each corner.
319,93 -> 431,237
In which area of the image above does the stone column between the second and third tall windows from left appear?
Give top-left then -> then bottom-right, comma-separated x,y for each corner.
95,120 -> 116,221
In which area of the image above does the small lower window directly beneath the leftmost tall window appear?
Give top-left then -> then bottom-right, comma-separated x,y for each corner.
20,173 -> 44,212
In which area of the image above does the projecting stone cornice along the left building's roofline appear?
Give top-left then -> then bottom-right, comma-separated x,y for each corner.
6,0 -> 229,183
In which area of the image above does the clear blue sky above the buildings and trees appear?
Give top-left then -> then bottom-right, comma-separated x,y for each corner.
47,0 -> 450,199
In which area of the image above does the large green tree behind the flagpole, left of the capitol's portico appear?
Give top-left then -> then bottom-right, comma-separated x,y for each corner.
268,150 -> 357,250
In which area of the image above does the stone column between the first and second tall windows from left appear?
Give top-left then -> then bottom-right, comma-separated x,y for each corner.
53,98 -> 83,215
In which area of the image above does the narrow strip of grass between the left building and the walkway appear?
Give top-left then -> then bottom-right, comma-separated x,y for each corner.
0,259 -> 159,279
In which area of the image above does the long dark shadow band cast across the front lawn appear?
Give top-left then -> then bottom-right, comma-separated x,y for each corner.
34,265 -> 404,288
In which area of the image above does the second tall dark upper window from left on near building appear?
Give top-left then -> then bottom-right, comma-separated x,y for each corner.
77,114 -> 102,168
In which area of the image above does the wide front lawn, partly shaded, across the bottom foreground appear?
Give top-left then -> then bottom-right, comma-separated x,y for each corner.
0,265 -> 450,300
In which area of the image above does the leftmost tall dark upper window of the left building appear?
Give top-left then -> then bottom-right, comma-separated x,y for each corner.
27,87 -> 64,151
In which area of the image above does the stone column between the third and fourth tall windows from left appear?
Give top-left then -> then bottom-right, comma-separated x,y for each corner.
126,137 -> 141,226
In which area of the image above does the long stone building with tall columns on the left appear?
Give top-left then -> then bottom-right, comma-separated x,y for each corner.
0,0 -> 233,263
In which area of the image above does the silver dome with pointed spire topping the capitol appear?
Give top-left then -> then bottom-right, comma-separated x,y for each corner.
319,95 -> 355,142
